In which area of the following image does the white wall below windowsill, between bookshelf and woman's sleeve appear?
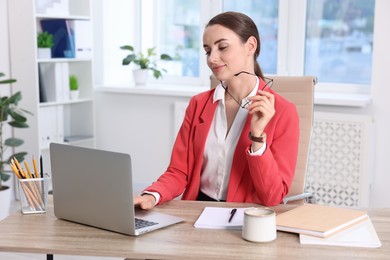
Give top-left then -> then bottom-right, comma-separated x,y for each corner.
95,92 -> 189,185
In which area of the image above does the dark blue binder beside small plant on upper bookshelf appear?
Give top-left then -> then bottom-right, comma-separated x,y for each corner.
41,19 -> 75,58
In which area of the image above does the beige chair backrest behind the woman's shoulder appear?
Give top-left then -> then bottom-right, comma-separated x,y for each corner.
210,76 -> 317,199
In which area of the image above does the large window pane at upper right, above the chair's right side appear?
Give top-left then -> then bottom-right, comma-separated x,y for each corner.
304,0 -> 374,84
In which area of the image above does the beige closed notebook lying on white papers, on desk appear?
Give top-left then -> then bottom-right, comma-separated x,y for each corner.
276,204 -> 367,237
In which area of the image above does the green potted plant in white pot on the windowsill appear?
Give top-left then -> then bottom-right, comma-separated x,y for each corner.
120,45 -> 172,84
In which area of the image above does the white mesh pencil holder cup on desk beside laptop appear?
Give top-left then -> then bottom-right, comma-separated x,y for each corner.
19,174 -> 50,214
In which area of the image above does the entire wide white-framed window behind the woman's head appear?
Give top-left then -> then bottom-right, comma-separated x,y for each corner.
101,0 -> 375,93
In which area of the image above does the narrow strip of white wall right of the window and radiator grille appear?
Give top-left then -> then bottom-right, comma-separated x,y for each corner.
371,0 -> 390,207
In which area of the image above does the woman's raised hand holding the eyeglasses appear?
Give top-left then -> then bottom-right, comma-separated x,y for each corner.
248,90 -> 275,136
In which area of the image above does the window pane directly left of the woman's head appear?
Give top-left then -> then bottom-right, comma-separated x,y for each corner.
141,0 -> 201,77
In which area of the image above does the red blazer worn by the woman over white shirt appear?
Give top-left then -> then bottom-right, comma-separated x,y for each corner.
145,80 -> 299,206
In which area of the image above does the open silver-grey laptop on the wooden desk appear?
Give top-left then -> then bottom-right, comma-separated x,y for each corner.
50,143 -> 184,236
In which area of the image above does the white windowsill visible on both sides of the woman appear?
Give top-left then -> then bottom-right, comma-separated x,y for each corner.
95,85 -> 372,107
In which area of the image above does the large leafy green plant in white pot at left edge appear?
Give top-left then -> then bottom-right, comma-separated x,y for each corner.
0,72 -> 31,219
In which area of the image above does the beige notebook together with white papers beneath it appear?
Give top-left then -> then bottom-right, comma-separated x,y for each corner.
276,204 -> 381,247
